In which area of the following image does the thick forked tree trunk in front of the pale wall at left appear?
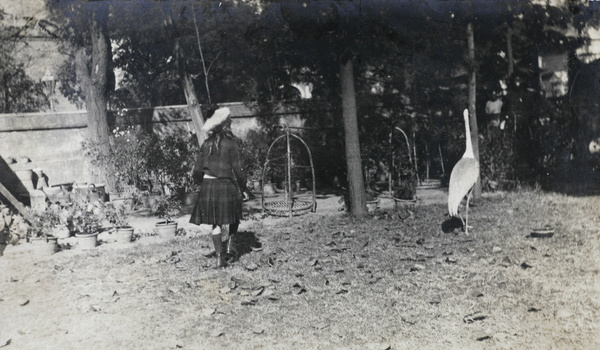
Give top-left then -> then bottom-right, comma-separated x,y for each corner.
75,18 -> 114,191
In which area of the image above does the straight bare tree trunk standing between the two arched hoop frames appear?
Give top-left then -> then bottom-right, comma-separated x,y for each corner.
340,55 -> 367,217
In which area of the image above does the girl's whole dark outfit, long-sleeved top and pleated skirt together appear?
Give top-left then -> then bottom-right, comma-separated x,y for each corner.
190,137 -> 246,225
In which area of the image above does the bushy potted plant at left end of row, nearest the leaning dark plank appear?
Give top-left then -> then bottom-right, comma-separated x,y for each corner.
27,203 -> 70,255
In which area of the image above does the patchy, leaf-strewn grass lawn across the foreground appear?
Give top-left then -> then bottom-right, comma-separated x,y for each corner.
0,191 -> 600,349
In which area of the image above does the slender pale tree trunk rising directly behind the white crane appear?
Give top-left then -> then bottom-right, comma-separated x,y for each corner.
467,23 -> 481,199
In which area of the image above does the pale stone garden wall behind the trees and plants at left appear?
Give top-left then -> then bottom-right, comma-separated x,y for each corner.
0,103 -> 310,190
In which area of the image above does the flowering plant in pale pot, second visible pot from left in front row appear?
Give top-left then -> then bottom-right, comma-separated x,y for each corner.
69,200 -> 104,249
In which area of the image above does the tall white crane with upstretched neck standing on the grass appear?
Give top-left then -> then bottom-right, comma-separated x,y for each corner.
448,109 -> 479,234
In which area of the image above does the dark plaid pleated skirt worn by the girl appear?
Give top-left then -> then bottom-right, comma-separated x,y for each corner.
190,179 -> 242,225
